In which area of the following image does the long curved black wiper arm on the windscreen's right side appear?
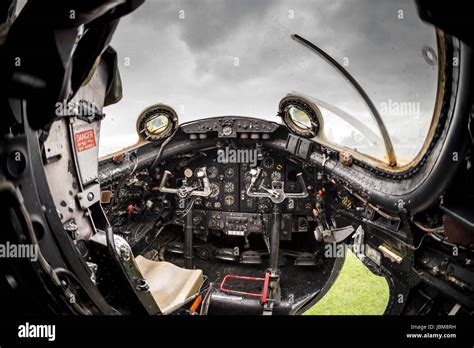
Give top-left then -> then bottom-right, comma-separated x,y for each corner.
291,34 -> 397,167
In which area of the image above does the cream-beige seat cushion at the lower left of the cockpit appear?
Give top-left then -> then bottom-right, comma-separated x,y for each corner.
135,256 -> 204,314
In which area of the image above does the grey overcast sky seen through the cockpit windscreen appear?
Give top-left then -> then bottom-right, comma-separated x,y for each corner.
101,0 -> 437,161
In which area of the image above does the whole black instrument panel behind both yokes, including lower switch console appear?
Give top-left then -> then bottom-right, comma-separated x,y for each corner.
164,151 -> 321,240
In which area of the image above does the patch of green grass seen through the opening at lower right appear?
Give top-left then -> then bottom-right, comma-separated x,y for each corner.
305,251 -> 389,315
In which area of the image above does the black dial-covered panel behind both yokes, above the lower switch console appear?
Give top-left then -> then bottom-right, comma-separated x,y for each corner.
170,153 -> 319,215
